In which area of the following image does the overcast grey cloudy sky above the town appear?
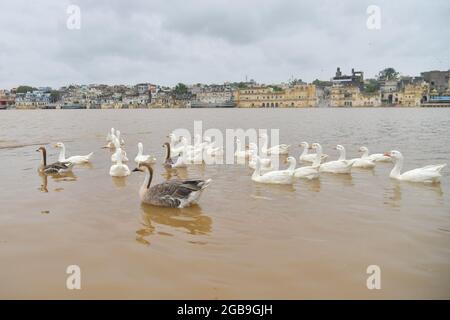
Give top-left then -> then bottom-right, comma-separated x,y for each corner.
0,0 -> 450,88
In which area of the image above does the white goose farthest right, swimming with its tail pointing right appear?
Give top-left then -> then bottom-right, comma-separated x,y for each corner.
384,150 -> 447,183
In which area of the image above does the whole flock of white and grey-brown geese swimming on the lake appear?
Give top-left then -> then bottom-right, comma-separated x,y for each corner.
36,128 -> 447,208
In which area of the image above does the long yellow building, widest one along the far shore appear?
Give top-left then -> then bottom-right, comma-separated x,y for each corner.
234,84 -> 317,108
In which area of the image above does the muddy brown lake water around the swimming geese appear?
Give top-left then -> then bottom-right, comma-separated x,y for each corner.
0,108 -> 450,299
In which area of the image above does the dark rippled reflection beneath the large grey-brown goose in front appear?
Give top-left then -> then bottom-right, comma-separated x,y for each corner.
136,203 -> 212,245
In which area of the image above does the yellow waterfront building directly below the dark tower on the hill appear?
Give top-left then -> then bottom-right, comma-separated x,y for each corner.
330,85 -> 381,107
